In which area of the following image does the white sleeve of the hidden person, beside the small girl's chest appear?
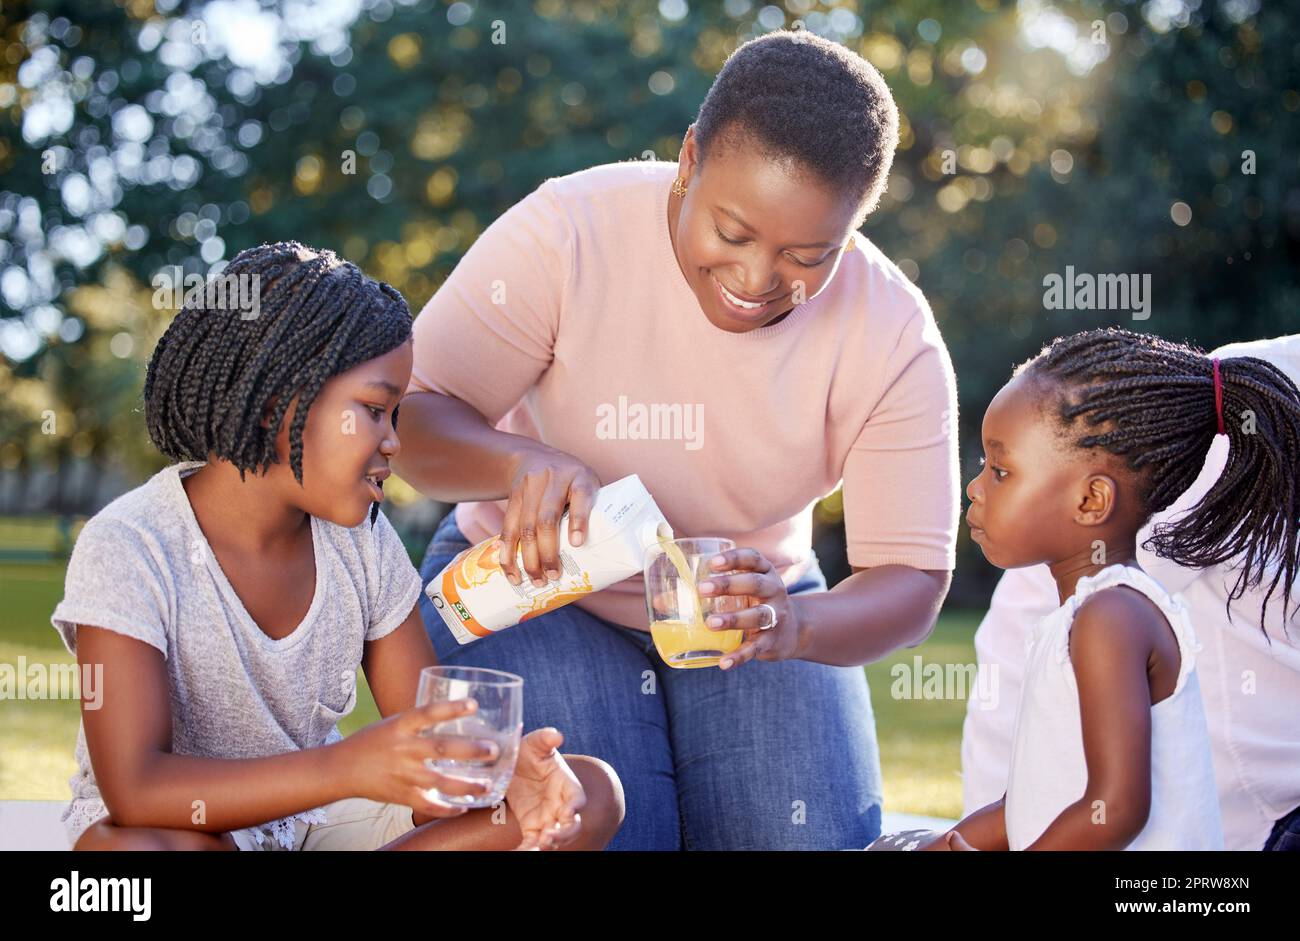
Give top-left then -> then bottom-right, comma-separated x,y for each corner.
962,565 -> 1060,816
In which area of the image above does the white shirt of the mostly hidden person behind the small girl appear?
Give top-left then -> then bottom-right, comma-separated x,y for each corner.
962,327 -> 1300,851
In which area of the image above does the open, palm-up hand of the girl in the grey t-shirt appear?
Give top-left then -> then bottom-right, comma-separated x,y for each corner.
506,728 -> 586,850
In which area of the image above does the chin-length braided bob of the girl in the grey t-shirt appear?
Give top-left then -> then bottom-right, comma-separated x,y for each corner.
144,242 -> 411,496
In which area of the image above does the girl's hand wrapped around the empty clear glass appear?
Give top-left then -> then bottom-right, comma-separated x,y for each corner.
330,699 -> 497,818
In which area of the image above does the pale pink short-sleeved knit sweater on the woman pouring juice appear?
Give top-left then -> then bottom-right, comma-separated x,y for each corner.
411,161 -> 959,629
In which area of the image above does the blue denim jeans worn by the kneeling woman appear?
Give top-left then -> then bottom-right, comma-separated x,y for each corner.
420,512 -> 881,850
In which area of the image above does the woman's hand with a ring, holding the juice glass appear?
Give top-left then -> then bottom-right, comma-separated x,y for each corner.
697,548 -> 802,669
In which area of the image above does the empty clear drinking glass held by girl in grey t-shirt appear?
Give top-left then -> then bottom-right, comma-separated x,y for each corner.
415,665 -> 524,807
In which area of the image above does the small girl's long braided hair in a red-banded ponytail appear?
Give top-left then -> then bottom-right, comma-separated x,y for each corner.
1015,328 -> 1300,637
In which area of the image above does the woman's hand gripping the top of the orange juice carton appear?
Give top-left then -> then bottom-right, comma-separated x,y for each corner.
498,446 -> 601,586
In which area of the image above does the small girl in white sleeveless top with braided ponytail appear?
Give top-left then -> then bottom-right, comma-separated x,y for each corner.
923,329 -> 1300,850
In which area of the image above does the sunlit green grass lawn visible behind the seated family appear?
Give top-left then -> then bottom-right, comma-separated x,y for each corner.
0,520 -> 980,818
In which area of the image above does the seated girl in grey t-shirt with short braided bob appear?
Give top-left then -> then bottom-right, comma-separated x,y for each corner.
52,242 -> 621,849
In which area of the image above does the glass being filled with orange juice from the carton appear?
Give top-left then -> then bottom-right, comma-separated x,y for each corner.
645,537 -> 745,669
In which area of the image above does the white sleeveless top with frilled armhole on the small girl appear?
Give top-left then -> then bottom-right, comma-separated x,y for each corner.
1005,563 -> 1223,850
